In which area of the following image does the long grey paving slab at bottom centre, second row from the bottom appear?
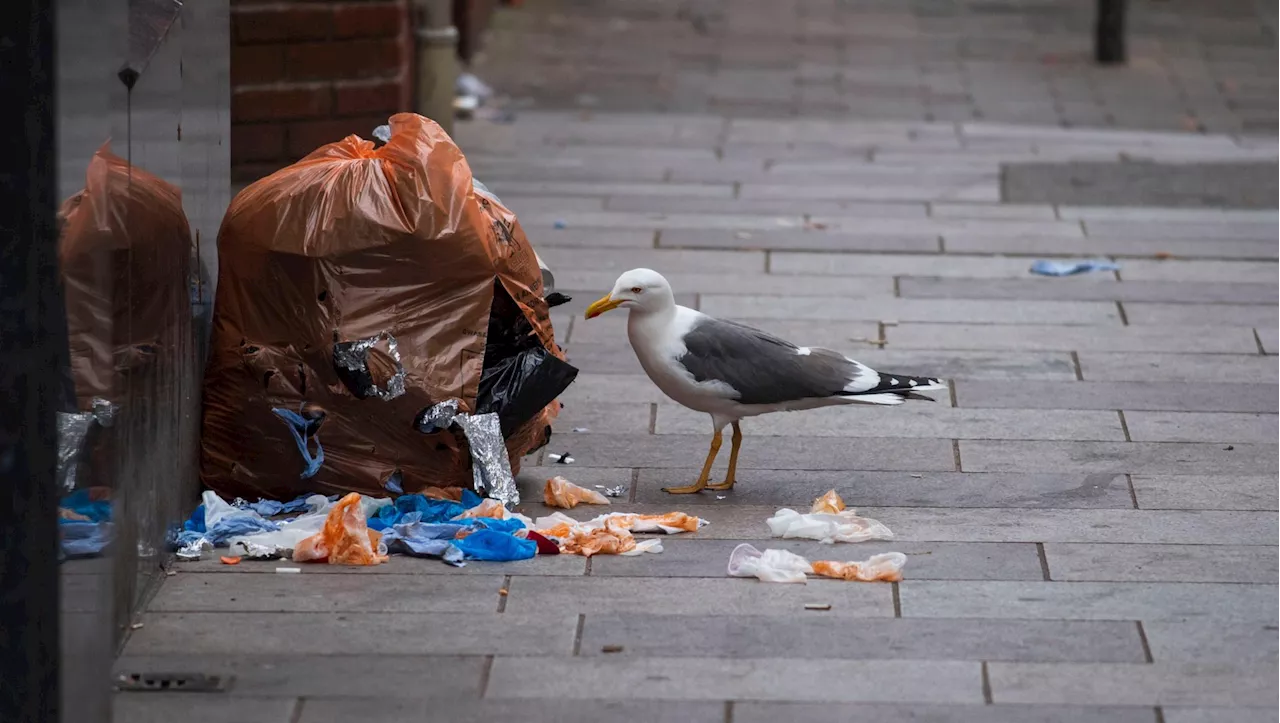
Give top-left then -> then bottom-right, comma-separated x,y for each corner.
489,656 -> 982,703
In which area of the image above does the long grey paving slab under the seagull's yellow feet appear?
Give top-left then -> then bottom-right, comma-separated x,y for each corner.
634,467 -> 1136,506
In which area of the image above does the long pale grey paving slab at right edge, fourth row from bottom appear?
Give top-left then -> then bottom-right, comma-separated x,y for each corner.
899,580 -> 1280,621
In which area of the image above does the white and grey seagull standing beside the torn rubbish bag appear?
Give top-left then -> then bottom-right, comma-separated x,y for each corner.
586,269 -> 947,494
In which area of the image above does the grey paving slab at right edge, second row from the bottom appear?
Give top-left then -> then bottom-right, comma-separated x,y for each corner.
987,663 -> 1280,706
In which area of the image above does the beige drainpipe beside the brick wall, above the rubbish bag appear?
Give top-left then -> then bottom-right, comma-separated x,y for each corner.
413,0 -> 458,134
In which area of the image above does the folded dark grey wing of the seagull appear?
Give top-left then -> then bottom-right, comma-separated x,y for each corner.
676,317 -> 879,404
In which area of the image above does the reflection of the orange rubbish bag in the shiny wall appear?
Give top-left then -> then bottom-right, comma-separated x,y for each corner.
58,143 -> 195,411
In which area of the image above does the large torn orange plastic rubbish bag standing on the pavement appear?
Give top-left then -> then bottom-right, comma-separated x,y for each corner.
201,114 -> 564,499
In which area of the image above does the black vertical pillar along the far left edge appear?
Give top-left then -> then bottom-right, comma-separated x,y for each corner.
0,0 -> 63,723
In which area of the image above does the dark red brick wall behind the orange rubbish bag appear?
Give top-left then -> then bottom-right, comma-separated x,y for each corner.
232,0 -> 412,182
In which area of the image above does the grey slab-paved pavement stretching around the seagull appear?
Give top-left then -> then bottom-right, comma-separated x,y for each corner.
118,0 -> 1280,723
